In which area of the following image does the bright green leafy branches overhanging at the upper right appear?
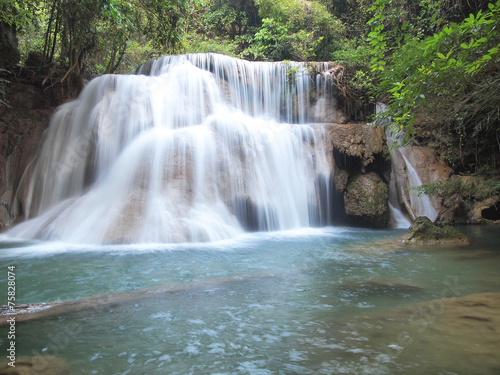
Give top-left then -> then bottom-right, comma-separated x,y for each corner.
369,0 -> 500,164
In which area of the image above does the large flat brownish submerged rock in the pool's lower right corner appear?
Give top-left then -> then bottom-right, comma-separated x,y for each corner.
337,294 -> 500,375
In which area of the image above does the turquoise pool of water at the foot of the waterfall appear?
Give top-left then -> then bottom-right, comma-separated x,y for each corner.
0,227 -> 500,375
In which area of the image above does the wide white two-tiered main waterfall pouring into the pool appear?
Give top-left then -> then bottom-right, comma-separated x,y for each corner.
11,54 -> 332,243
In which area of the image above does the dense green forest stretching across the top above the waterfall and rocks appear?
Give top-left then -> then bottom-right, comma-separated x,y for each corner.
0,0 -> 500,195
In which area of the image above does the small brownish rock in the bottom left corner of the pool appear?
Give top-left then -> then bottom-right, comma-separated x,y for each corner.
0,355 -> 72,375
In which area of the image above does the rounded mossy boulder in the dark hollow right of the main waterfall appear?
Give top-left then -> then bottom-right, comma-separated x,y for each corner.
344,172 -> 389,228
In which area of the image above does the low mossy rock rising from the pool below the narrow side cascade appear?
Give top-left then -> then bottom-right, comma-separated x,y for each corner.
399,216 -> 470,245
